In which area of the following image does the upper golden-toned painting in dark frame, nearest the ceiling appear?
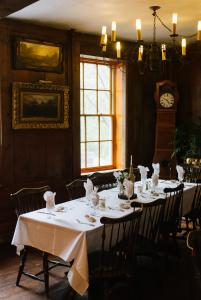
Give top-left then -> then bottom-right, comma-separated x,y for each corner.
14,38 -> 63,73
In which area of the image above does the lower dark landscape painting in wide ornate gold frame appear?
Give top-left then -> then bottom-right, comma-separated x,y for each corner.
12,82 -> 69,129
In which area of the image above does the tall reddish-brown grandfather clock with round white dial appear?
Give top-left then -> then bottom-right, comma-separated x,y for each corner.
153,80 -> 179,178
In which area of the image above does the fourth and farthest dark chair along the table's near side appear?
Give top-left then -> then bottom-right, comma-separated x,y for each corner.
184,184 -> 201,231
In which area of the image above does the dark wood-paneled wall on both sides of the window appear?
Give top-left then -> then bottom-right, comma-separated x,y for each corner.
0,21 -> 201,243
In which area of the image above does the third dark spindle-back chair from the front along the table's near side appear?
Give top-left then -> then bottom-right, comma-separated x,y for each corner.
159,184 -> 184,257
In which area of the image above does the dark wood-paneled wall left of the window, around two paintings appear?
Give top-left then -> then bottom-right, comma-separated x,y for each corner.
0,21 -> 79,242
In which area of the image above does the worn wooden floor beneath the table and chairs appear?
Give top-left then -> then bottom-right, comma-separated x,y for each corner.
0,242 -> 201,300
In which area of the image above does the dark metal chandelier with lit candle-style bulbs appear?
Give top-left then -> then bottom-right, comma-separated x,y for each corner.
100,6 -> 201,74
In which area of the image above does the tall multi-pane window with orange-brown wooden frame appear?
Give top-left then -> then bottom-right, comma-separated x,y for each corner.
80,58 -> 115,172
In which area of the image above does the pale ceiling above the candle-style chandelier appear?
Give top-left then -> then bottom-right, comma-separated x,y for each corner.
8,0 -> 201,41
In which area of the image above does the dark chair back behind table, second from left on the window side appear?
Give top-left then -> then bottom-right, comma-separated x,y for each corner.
66,179 -> 86,201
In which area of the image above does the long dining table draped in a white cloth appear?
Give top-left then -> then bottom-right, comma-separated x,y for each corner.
12,180 -> 196,295
